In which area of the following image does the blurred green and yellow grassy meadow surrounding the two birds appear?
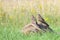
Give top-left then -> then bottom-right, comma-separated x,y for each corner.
0,0 -> 60,40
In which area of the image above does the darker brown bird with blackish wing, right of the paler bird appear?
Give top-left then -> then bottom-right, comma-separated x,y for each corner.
37,14 -> 53,32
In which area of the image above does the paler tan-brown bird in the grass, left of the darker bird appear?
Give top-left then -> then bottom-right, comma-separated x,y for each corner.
22,15 -> 43,34
